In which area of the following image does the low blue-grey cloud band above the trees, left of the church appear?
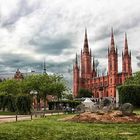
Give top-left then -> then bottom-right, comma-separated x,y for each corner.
0,54 -> 72,74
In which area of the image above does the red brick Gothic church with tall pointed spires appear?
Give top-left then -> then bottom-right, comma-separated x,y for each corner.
73,29 -> 132,98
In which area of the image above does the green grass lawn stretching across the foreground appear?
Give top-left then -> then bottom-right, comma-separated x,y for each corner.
0,115 -> 140,140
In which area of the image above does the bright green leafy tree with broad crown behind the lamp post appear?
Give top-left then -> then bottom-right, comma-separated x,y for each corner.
22,74 -> 66,110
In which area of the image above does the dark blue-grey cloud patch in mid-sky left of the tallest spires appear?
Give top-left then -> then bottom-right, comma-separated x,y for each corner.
29,35 -> 74,55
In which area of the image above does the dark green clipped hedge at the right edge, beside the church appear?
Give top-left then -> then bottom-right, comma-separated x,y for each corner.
118,85 -> 140,107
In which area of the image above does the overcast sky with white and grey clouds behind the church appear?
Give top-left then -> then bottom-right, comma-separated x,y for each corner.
0,0 -> 140,86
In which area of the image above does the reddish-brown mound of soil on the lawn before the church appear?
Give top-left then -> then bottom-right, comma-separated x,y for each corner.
63,111 -> 140,123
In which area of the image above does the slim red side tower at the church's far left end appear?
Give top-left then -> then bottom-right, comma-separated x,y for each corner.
73,54 -> 79,97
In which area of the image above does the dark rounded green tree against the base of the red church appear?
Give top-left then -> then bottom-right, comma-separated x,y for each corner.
77,88 -> 92,98
